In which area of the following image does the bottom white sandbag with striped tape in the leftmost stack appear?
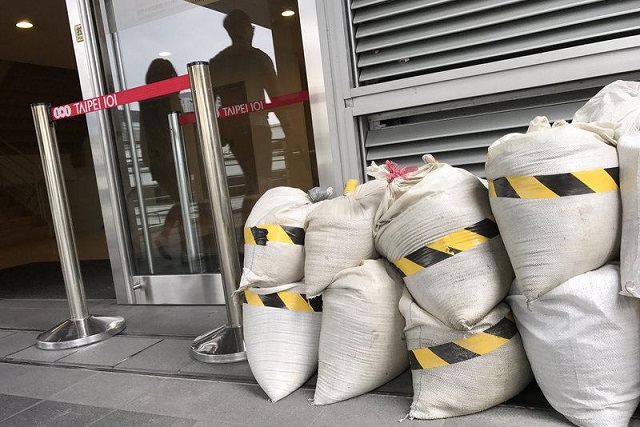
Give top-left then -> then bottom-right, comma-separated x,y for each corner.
242,283 -> 322,402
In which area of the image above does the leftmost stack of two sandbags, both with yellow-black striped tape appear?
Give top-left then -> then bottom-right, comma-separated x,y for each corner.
239,187 -> 330,402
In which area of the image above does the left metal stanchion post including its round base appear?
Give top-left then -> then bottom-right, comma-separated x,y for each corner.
31,103 -> 125,350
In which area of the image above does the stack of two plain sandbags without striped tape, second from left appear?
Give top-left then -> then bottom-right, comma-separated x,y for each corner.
305,181 -> 408,405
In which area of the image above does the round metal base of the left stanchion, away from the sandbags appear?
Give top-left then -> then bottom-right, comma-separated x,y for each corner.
36,316 -> 126,350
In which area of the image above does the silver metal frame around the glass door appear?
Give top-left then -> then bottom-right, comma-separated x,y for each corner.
66,0 -> 344,305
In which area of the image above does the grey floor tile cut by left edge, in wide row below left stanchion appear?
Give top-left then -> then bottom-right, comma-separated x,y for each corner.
0,363 -> 95,399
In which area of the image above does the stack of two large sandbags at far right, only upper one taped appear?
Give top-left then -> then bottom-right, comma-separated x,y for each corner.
486,111 -> 640,426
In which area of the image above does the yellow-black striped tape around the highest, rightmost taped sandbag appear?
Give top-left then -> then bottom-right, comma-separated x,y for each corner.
489,168 -> 620,199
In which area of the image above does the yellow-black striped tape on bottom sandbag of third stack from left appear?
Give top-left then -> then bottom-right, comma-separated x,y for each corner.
409,313 -> 518,370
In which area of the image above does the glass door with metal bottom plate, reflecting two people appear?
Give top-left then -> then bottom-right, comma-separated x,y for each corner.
86,0 -> 318,304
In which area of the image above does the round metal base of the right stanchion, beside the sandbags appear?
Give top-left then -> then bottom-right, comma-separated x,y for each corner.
191,325 -> 247,363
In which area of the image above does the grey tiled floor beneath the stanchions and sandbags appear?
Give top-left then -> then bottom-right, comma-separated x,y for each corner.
0,299 -> 640,427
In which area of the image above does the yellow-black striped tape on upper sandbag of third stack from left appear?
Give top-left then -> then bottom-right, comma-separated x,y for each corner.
393,217 -> 500,276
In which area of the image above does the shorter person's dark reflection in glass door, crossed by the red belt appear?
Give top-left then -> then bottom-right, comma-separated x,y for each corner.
140,58 -> 184,259
